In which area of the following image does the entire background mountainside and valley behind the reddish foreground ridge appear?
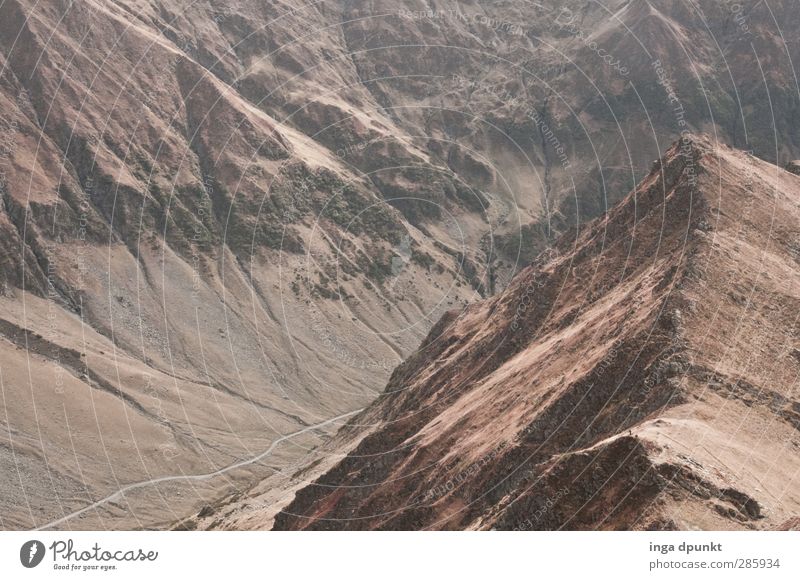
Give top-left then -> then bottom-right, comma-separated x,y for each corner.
0,0 -> 800,529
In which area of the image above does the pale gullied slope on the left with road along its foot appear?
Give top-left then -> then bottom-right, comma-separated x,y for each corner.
0,0 -> 485,529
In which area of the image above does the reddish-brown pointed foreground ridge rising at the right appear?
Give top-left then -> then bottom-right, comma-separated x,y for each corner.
275,135 -> 800,529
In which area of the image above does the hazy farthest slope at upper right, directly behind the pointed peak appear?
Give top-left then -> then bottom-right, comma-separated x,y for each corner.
334,0 -> 800,268
